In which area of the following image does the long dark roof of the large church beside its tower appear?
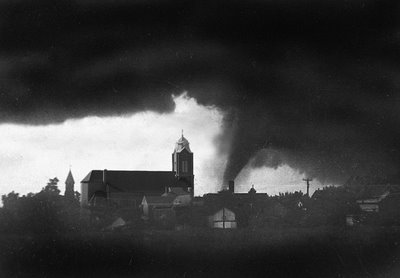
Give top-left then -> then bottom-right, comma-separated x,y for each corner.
81,170 -> 178,192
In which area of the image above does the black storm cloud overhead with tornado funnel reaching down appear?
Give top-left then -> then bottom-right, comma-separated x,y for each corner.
0,0 -> 400,185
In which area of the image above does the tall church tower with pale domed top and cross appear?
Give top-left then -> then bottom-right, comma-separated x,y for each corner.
172,132 -> 194,194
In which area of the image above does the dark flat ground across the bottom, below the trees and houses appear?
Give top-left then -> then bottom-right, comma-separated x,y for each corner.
0,227 -> 400,277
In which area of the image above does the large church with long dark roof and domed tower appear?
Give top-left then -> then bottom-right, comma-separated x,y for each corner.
81,134 -> 194,208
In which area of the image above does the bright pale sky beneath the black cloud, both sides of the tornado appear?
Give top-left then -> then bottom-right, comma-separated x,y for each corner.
0,94 -> 318,198
